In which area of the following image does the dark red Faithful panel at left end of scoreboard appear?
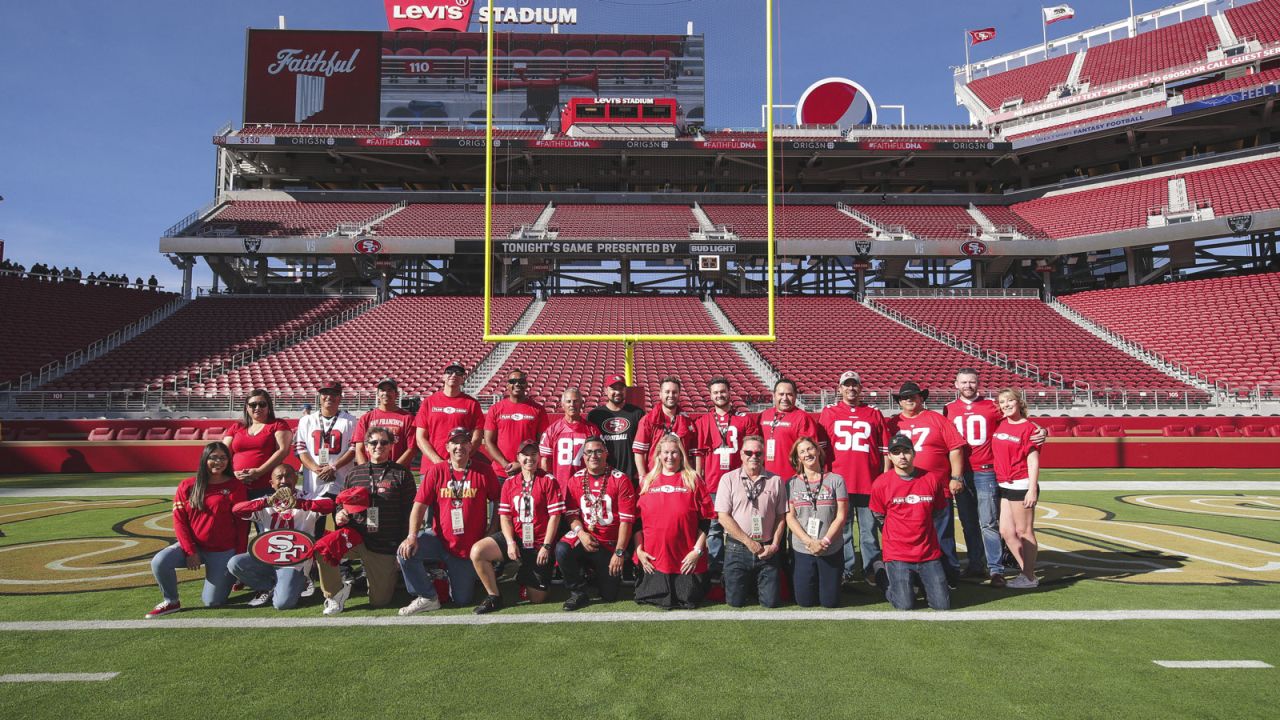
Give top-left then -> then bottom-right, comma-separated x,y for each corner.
244,30 -> 381,124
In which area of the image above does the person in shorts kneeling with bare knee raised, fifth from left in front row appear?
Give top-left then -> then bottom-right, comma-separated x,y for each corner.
471,439 -> 564,615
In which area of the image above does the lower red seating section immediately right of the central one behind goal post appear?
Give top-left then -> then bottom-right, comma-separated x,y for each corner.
716,296 -> 1048,397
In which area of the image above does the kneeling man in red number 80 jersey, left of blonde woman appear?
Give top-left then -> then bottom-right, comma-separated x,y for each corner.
556,437 -> 636,611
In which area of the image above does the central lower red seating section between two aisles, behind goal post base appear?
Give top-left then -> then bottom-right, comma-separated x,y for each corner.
484,296 -> 768,411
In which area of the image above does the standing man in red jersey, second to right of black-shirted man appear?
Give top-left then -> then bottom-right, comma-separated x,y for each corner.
694,378 -> 760,577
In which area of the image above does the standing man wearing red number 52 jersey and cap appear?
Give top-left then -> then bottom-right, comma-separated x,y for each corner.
818,370 -> 890,584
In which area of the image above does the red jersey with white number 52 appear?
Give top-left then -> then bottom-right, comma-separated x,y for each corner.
818,402 -> 890,495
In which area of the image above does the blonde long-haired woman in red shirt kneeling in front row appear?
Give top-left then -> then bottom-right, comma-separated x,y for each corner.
635,434 -> 714,610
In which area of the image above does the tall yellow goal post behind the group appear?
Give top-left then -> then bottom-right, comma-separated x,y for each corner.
483,0 -> 777,386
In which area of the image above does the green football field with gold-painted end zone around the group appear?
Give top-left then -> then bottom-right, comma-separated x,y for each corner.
0,470 -> 1280,719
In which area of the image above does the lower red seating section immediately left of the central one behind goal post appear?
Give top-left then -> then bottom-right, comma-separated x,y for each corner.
193,296 -> 530,396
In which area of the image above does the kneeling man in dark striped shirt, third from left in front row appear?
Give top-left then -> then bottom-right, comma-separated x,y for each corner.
317,425 -> 417,615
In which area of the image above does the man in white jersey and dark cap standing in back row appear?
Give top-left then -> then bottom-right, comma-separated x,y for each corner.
293,380 -> 356,500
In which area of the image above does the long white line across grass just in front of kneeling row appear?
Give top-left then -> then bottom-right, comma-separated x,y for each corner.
0,610 -> 1280,633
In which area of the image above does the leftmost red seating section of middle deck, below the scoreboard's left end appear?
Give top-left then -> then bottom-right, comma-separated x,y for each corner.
201,200 -> 392,237
